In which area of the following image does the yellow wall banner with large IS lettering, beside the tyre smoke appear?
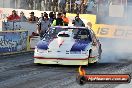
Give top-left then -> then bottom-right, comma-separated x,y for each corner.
93,24 -> 132,39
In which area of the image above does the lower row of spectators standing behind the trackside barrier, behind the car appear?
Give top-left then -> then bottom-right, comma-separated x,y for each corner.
2,10 -> 88,38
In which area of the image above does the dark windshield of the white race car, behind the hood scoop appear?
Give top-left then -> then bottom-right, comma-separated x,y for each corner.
44,27 -> 91,41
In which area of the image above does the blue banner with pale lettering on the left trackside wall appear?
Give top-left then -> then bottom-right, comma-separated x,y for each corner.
0,31 -> 28,54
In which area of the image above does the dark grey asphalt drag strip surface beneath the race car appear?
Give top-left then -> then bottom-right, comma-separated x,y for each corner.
0,53 -> 132,88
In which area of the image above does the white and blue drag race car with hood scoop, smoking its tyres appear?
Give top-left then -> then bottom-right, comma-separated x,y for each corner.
34,26 -> 102,65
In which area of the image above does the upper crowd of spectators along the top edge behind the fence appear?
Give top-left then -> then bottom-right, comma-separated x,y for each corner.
18,0 -> 98,13
